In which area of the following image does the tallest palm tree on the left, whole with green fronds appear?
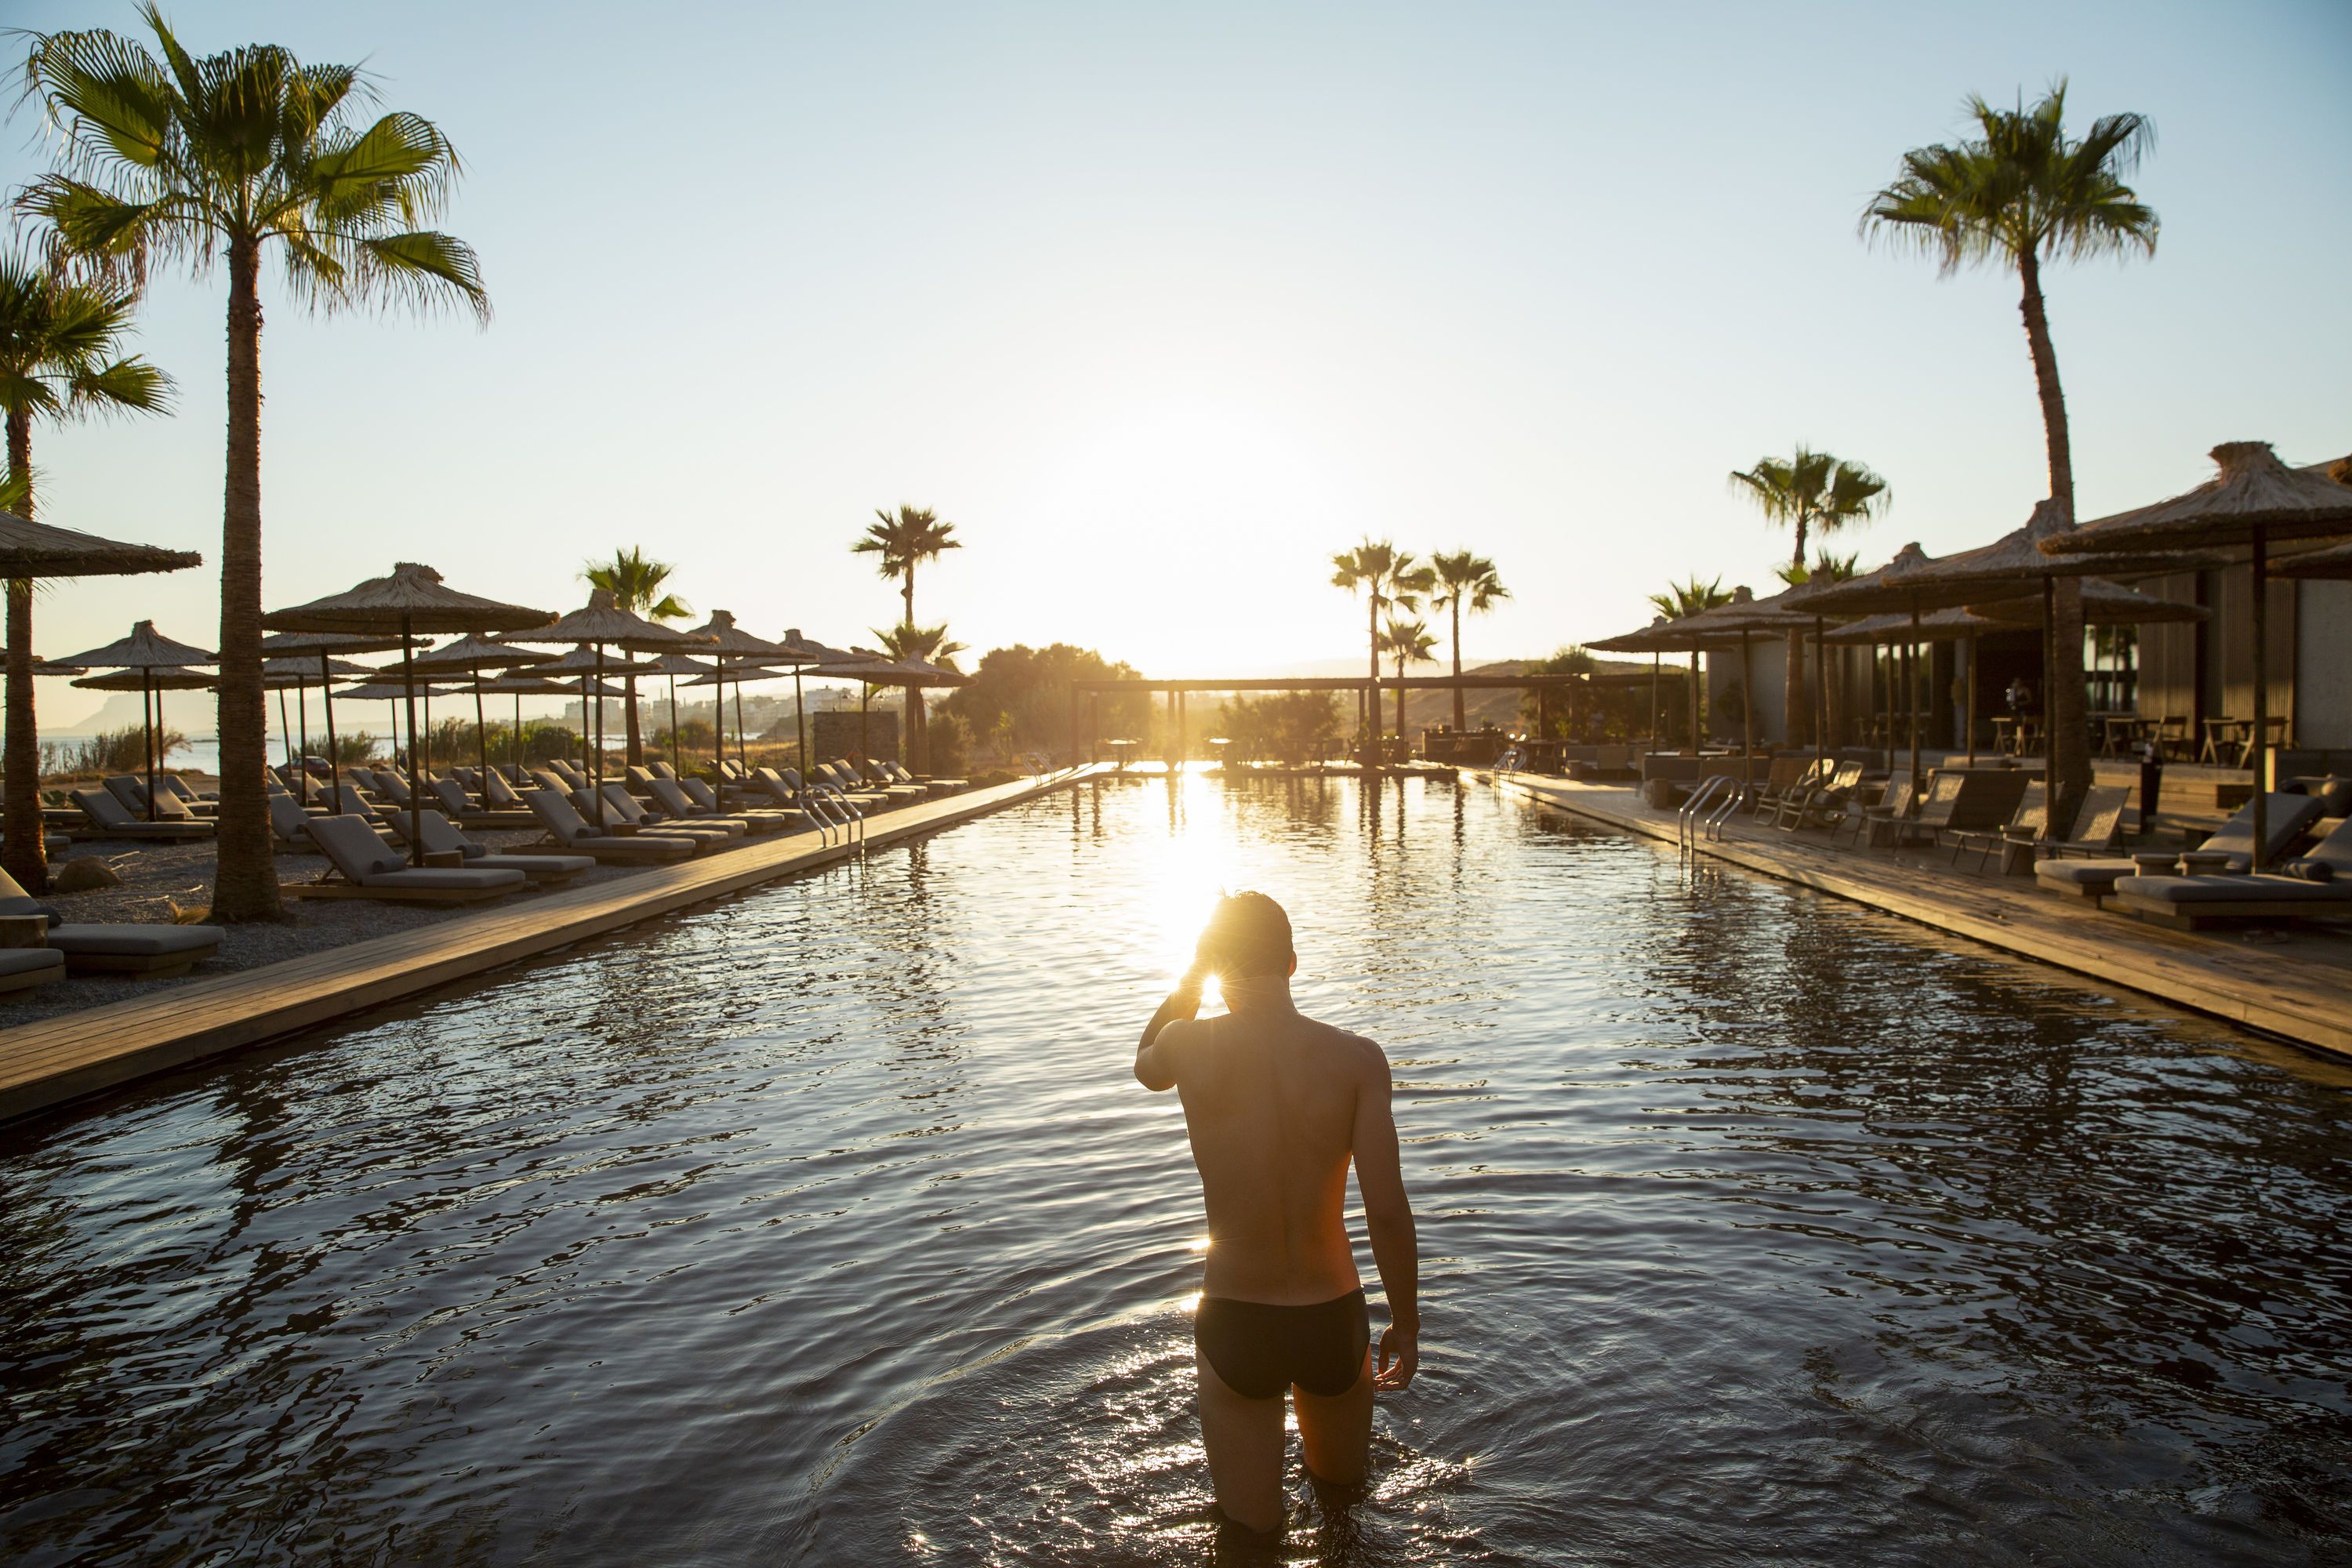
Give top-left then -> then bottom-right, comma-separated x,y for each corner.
19,0 -> 489,921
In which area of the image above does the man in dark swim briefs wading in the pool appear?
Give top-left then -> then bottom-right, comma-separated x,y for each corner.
1136,893 -> 1421,1530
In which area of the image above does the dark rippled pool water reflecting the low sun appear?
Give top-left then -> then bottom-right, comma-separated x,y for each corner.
0,779 -> 2352,1568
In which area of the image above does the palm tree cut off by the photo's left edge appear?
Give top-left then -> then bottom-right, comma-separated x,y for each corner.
0,252 -> 172,893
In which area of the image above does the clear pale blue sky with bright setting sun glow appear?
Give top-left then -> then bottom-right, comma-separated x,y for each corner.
0,0 -> 2352,727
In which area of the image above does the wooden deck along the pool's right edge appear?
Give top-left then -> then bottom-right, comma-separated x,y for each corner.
1496,774 -> 2352,1055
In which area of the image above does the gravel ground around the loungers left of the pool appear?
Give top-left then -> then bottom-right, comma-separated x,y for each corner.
0,827 -> 668,1029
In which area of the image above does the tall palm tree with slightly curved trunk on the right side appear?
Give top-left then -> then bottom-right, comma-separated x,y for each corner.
1860,80 -> 2159,820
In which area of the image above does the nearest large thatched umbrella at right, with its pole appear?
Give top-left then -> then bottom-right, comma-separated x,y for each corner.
2042,442 -> 2352,869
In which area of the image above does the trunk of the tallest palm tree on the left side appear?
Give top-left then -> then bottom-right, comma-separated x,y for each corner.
212,238 -> 285,921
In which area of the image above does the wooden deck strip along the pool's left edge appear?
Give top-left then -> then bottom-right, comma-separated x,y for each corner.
0,769 -> 1103,1119
